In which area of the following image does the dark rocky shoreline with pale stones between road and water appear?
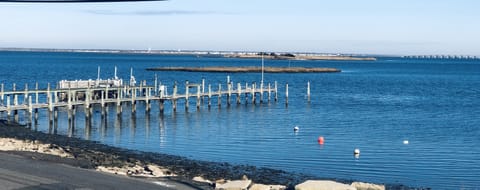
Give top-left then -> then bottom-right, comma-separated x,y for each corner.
0,120 -> 409,189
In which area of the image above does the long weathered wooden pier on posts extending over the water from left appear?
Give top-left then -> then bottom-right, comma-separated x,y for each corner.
0,80 -> 282,123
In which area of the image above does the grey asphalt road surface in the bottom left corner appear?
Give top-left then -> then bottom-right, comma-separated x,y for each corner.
0,152 -> 204,190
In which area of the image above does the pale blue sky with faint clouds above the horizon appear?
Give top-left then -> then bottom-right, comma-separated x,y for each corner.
0,0 -> 480,56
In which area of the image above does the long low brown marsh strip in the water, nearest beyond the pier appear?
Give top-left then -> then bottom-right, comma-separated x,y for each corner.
146,67 -> 341,73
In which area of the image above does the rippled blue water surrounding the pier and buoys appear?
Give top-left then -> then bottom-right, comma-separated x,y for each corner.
0,52 -> 480,189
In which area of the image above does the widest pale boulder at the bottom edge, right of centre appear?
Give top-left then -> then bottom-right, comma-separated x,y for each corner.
295,180 -> 356,190
